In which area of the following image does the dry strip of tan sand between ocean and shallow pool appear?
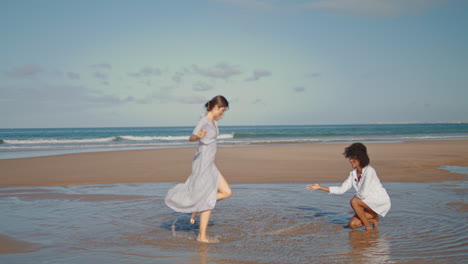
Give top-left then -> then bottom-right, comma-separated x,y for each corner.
0,140 -> 468,187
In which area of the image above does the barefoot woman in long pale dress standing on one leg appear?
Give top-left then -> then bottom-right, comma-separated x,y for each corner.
164,96 -> 232,243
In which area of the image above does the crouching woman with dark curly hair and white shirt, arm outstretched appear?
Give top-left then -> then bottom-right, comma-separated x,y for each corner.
307,143 -> 391,231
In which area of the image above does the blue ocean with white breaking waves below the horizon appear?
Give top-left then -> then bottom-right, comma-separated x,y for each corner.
0,123 -> 468,159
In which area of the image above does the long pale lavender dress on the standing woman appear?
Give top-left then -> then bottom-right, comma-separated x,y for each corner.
164,116 -> 219,213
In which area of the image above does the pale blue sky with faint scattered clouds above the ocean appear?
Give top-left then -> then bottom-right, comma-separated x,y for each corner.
0,0 -> 468,128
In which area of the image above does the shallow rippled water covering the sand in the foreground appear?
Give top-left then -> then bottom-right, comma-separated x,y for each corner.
0,178 -> 468,264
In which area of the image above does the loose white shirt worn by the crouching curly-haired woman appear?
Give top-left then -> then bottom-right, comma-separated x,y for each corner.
330,166 -> 391,216
